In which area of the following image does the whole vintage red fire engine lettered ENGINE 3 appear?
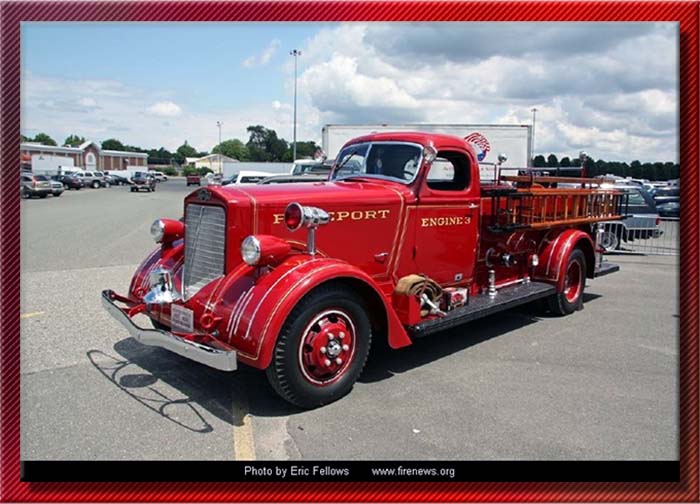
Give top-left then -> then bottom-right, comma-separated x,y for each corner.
102,132 -> 623,407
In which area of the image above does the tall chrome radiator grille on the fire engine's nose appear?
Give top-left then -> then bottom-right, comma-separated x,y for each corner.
183,205 -> 226,299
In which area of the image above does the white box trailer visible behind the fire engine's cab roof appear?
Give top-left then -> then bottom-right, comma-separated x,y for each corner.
321,124 -> 532,168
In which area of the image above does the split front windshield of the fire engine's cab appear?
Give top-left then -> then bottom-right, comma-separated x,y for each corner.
331,142 -> 423,184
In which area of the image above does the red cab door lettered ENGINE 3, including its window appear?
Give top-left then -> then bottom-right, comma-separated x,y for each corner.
413,151 -> 481,286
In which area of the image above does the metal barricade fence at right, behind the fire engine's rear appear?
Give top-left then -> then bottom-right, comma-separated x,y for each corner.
601,217 -> 680,255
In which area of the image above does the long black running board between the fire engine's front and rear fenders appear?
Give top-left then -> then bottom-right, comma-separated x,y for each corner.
407,282 -> 557,338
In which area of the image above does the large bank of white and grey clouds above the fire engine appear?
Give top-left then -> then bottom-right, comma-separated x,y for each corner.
287,23 -> 678,161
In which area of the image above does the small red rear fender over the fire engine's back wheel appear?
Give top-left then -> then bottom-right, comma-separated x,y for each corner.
534,229 -> 595,291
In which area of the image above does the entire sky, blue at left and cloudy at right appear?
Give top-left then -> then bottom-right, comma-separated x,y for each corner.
21,22 -> 679,162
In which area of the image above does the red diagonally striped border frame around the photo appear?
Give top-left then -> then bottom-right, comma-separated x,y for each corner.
0,1 -> 700,502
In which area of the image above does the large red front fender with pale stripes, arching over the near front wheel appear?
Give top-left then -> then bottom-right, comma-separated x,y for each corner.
222,255 -> 411,369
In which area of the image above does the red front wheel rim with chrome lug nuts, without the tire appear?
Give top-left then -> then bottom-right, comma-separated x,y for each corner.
299,309 -> 357,386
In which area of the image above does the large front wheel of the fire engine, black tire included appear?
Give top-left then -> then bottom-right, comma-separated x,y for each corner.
266,285 -> 372,408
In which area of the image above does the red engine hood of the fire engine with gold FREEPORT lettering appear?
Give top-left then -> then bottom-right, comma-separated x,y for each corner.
186,180 -> 411,277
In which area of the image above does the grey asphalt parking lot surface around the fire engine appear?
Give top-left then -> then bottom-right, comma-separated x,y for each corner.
21,179 -> 679,460
